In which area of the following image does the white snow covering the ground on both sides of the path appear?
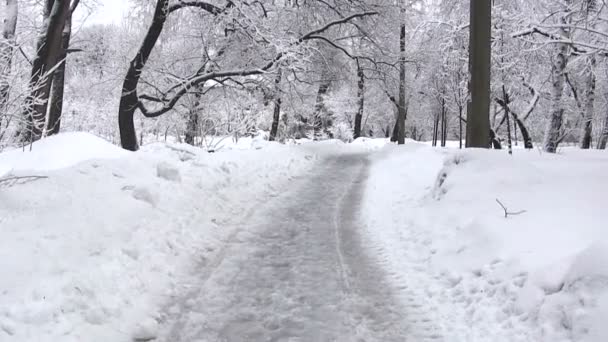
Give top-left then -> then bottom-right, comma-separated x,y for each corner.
0,133 -> 608,342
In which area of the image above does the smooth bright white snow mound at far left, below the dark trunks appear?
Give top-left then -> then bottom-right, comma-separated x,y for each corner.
0,132 -> 129,176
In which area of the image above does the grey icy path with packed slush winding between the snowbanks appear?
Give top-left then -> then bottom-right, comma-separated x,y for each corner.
157,154 -> 408,342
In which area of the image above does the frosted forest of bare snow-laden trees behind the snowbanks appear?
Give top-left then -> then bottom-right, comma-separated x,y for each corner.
0,0 -> 608,152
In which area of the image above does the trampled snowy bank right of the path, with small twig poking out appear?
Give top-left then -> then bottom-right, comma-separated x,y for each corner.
363,143 -> 608,342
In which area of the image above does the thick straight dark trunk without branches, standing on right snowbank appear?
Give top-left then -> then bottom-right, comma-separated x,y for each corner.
467,0 -> 492,148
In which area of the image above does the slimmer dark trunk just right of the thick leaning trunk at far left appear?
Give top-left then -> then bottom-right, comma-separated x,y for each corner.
46,3 -> 77,135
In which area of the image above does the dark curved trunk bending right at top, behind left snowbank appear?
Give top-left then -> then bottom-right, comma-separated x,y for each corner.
118,0 -> 169,151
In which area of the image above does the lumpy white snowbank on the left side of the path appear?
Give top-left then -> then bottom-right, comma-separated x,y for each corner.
0,133 -> 318,342
